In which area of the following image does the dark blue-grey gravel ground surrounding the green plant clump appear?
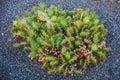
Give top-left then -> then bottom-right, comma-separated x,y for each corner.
0,0 -> 120,80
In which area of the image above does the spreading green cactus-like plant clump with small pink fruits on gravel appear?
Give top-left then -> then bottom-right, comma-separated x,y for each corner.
10,3 -> 109,75
